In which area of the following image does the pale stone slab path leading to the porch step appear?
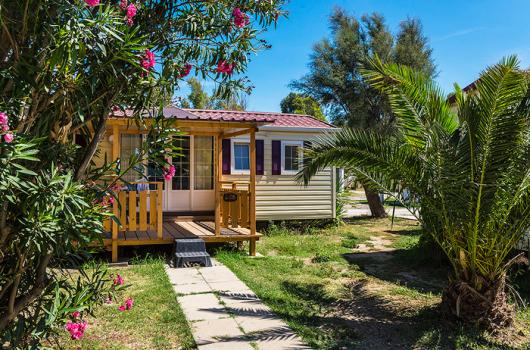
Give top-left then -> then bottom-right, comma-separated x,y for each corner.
166,261 -> 310,350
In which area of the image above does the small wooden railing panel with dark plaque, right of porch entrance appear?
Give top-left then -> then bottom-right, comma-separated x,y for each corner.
219,182 -> 250,228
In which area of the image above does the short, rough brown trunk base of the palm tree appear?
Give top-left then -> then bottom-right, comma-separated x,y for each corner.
442,277 -> 515,332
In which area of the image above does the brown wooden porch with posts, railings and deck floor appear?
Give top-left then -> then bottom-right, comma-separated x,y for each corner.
99,120 -> 261,262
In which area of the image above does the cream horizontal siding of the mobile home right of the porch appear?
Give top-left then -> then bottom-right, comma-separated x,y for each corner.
223,131 -> 335,221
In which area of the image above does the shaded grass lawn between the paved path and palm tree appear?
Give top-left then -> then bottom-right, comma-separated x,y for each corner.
217,219 -> 530,349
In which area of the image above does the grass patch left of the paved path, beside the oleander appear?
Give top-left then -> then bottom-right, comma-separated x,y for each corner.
53,259 -> 195,350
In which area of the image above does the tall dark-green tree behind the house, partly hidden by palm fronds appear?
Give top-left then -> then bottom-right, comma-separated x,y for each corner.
291,8 -> 435,217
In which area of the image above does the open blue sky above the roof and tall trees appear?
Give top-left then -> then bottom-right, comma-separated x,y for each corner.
185,0 -> 530,112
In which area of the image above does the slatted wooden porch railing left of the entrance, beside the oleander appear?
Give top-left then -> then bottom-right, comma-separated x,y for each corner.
105,182 -> 163,240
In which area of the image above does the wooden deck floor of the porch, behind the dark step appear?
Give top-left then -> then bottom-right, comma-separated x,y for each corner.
98,220 -> 261,247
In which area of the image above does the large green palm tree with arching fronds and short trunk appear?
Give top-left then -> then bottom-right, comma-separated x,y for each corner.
298,57 -> 530,329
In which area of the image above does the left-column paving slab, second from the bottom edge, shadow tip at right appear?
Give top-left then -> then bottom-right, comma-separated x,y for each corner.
177,293 -> 229,321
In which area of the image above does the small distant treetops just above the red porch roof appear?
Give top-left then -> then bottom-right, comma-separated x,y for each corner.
180,77 -> 247,111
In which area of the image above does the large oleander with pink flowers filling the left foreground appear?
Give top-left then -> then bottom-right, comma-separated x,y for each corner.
0,0 -> 283,348
